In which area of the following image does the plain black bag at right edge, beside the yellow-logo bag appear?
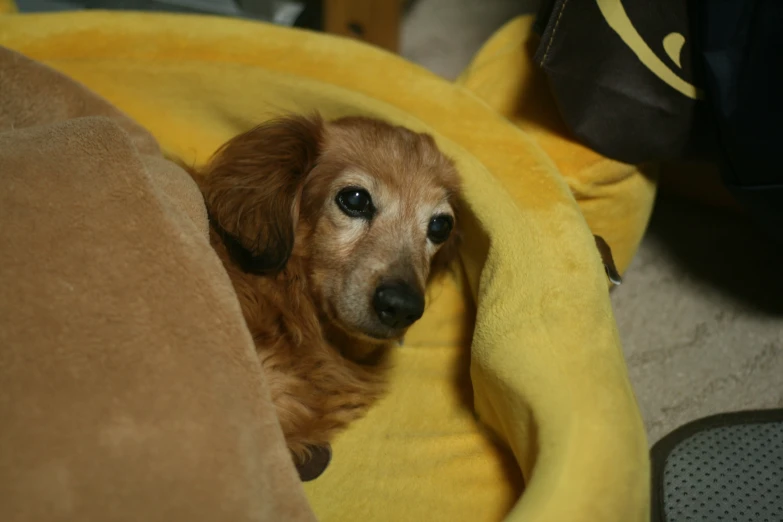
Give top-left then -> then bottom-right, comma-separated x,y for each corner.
698,0 -> 783,239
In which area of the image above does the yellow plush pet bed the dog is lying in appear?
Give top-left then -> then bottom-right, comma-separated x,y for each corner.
0,12 -> 649,522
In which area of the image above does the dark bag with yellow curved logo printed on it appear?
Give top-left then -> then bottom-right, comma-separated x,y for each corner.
535,0 -> 703,164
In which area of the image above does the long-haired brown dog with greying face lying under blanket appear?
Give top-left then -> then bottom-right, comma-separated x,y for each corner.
188,116 -> 459,472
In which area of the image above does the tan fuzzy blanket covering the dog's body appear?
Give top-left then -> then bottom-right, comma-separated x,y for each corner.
0,48 -> 314,522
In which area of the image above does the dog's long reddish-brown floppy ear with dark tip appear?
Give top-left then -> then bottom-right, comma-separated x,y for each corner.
200,115 -> 323,274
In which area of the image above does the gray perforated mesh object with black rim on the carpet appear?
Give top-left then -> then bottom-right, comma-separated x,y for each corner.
652,410 -> 783,522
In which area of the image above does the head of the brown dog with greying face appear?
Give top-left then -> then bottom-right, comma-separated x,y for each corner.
202,116 -> 459,340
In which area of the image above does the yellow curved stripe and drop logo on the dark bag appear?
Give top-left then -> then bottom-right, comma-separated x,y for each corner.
595,0 -> 703,100
